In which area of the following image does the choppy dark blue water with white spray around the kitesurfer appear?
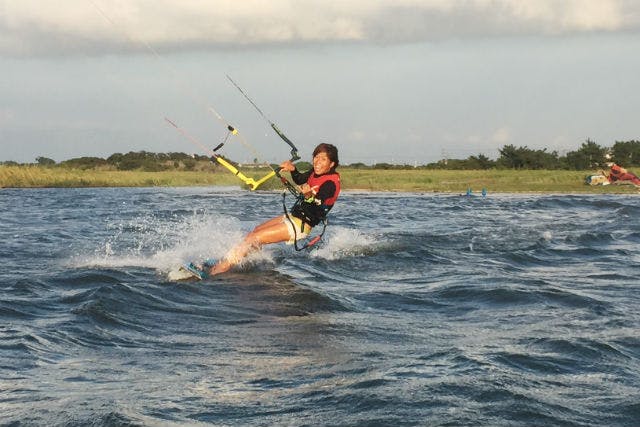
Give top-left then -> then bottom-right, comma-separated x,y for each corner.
0,188 -> 640,426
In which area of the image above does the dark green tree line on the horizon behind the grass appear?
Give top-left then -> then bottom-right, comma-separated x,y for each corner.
3,139 -> 640,172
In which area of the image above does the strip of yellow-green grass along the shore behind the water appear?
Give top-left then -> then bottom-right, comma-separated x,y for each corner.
0,166 -> 638,194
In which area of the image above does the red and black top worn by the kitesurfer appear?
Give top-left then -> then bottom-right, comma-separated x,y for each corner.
291,169 -> 340,227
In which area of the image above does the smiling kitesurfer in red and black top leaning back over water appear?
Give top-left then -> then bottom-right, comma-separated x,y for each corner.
193,143 -> 340,278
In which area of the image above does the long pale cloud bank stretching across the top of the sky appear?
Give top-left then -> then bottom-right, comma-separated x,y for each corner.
0,0 -> 640,56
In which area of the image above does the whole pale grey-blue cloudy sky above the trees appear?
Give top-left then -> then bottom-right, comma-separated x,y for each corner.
0,0 -> 640,165
